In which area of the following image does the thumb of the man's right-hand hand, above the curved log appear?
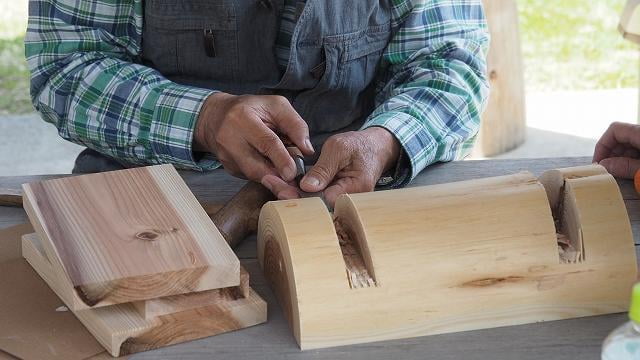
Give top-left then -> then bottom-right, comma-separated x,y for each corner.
300,138 -> 351,192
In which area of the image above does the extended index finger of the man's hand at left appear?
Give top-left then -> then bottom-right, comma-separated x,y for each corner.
269,96 -> 314,156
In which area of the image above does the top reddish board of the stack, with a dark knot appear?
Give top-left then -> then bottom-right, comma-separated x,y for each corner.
24,165 -> 240,310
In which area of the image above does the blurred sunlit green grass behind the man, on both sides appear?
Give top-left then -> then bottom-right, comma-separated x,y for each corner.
0,0 -> 640,115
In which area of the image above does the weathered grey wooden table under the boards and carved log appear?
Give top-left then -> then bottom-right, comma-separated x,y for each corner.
0,157 -> 640,360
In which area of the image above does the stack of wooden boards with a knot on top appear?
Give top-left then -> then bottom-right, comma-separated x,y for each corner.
22,165 -> 266,356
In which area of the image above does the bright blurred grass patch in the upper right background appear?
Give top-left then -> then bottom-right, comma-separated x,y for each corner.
517,0 -> 640,90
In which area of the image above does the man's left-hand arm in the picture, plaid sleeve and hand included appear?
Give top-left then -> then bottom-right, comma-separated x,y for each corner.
25,0 -> 313,181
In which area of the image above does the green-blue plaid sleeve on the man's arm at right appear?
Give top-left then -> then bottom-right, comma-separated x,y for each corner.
363,0 -> 489,187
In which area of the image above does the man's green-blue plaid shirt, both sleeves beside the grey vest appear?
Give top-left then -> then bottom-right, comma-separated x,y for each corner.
25,0 -> 488,180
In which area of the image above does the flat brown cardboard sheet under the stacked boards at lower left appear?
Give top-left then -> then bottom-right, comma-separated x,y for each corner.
0,224 -> 104,360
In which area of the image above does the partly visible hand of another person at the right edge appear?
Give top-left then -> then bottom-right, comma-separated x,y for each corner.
593,122 -> 640,179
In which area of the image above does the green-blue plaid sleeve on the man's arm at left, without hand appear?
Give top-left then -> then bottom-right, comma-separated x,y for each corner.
25,0 -> 219,170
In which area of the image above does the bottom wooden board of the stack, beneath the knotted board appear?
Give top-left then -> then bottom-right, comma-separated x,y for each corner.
22,234 -> 267,356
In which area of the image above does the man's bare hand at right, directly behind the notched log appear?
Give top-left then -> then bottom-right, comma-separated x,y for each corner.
262,127 -> 400,206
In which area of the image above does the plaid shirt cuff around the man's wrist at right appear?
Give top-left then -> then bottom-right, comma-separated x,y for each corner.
362,111 -> 437,189
